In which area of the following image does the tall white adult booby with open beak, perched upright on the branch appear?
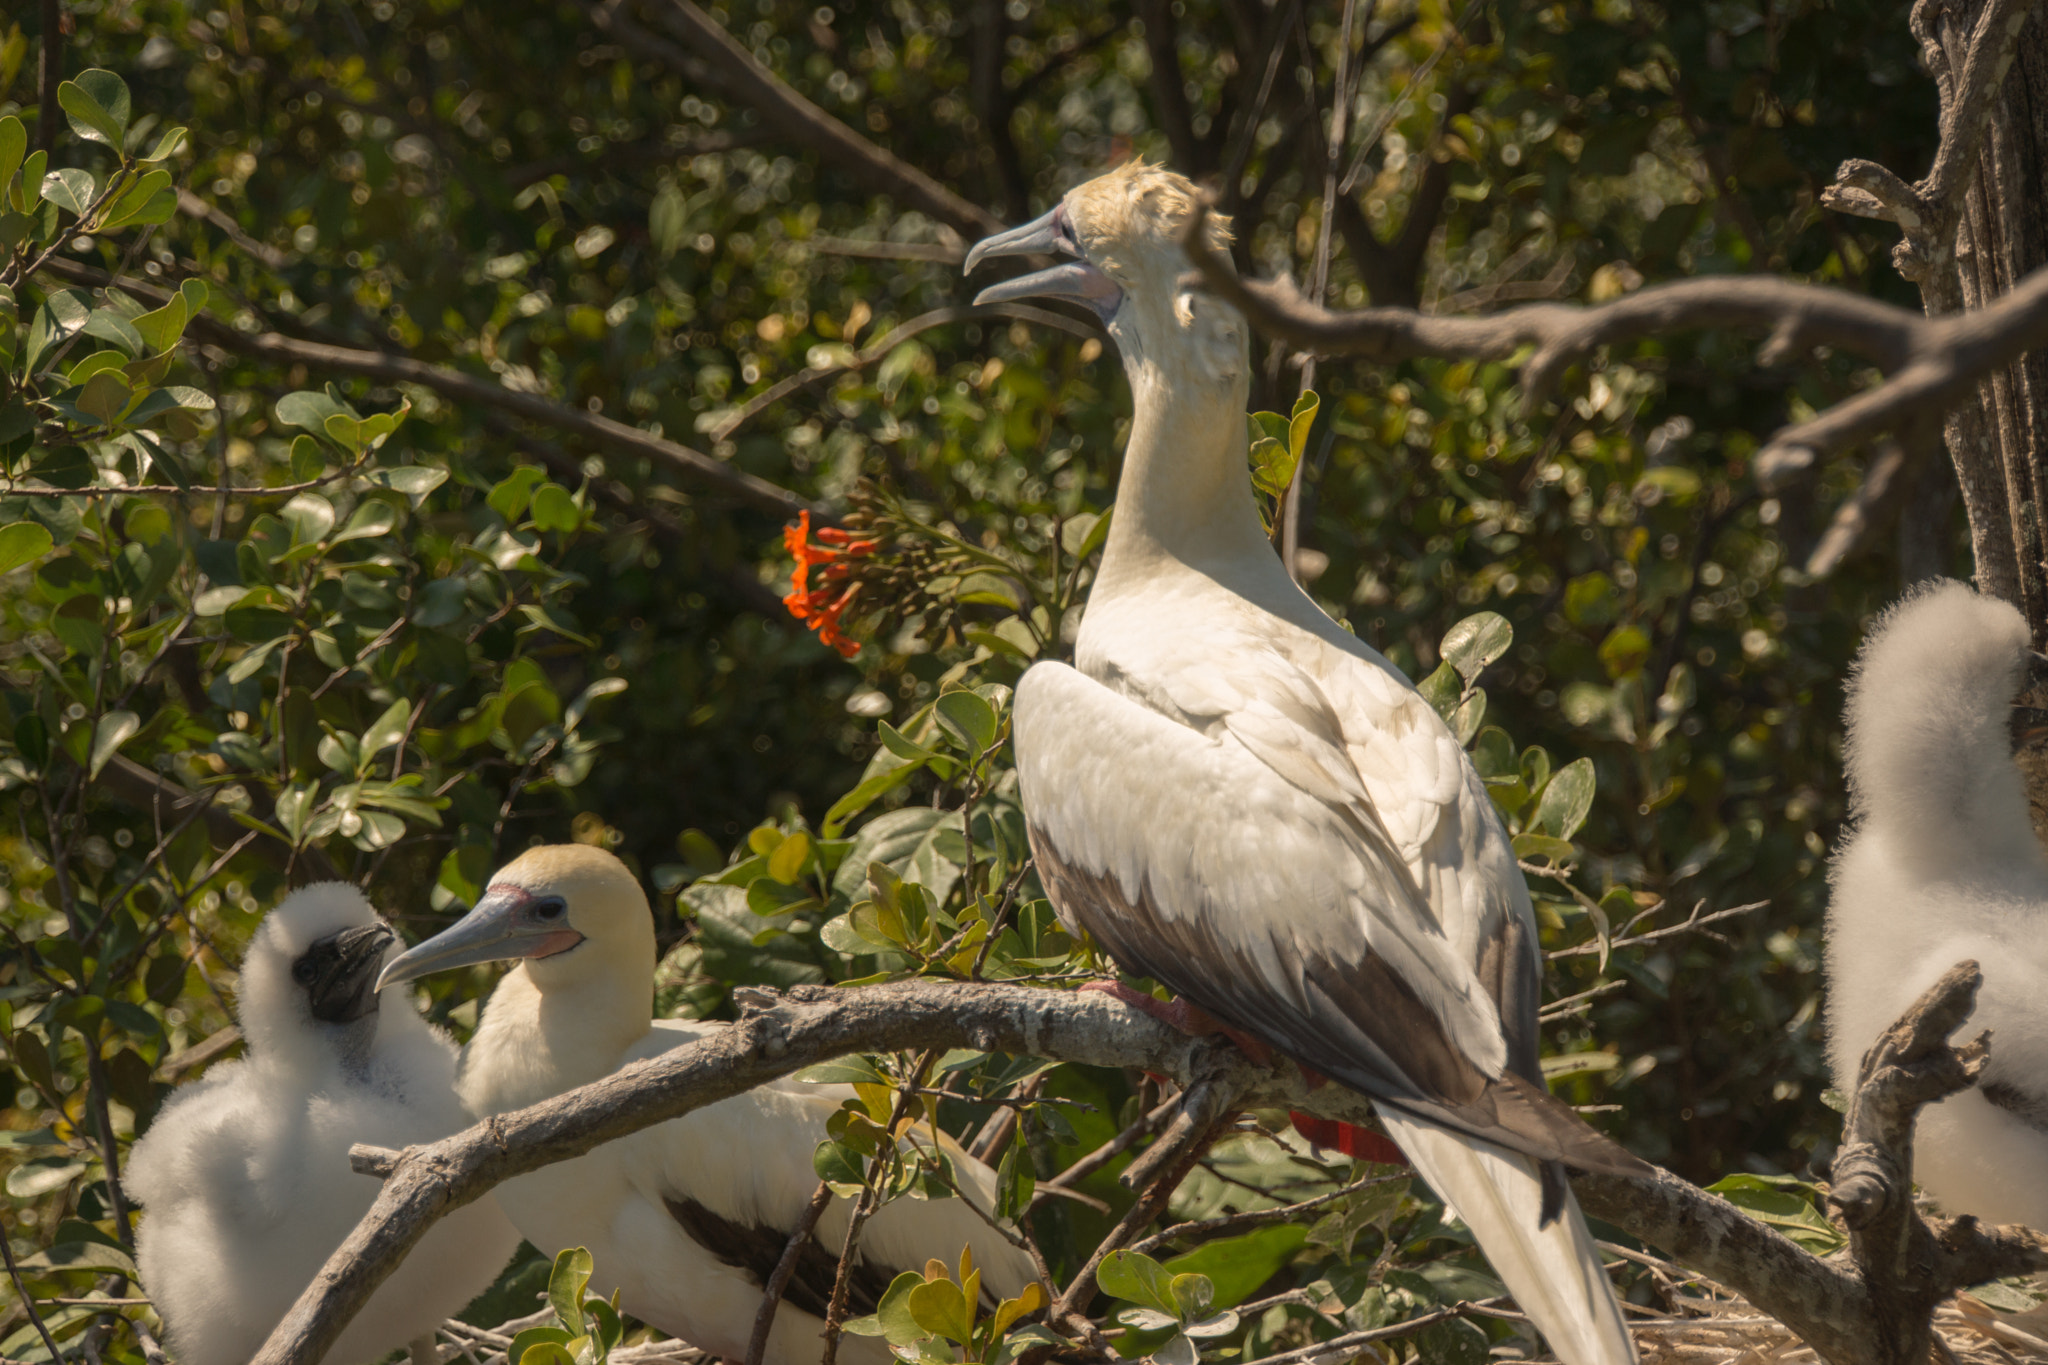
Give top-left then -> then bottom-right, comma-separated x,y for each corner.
967,164 -> 1645,1365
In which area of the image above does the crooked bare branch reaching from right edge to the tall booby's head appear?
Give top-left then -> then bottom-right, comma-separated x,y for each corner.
1186,215 -> 2048,507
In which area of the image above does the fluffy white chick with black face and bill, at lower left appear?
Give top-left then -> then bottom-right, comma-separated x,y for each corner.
125,882 -> 518,1365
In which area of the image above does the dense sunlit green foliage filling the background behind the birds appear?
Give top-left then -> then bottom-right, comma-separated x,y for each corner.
0,0 -> 1968,1359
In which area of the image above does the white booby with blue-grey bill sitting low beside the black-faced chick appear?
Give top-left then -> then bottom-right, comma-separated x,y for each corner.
379,843 -> 1036,1365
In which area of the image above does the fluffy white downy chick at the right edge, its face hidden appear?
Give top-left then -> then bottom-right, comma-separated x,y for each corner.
1827,581 -> 2048,1228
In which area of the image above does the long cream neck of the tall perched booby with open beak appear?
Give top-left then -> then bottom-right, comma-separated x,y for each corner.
1096,304 -> 1278,593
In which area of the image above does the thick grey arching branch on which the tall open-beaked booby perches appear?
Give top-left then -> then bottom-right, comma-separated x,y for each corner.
256,982 -> 1949,1365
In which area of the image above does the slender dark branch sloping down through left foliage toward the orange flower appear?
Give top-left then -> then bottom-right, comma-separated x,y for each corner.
43,260 -> 829,518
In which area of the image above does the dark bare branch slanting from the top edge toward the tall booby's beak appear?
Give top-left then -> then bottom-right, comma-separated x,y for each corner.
590,0 -> 1008,237
